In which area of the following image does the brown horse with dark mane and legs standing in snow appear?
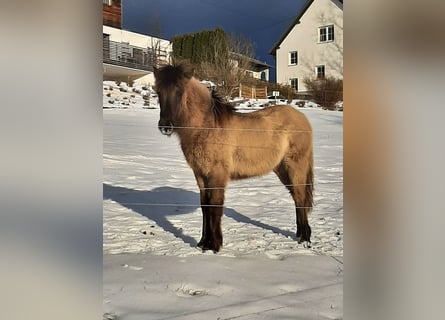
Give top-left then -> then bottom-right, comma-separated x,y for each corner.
154,64 -> 313,252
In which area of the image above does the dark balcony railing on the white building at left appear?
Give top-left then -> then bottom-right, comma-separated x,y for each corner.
102,39 -> 167,71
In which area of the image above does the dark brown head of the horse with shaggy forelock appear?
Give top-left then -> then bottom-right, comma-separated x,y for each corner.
154,64 -> 193,136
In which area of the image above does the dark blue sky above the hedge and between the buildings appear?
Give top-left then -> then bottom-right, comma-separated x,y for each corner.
122,0 -> 306,81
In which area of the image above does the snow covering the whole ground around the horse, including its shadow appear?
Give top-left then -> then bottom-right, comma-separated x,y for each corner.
103,82 -> 343,319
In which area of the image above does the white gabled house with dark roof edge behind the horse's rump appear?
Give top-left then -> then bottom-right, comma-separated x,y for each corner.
269,0 -> 343,92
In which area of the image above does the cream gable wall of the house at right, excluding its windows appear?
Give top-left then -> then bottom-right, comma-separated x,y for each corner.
276,0 -> 343,92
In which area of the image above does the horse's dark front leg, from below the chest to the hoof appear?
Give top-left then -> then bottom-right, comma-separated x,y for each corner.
198,175 -> 227,252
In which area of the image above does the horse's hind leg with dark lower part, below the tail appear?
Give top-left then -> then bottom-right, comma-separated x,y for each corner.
274,161 -> 313,246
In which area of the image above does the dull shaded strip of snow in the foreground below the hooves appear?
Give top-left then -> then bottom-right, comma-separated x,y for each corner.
103,254 -> 342,320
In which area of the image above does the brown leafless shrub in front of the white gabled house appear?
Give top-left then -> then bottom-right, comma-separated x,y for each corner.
303,77 -> 343,110
